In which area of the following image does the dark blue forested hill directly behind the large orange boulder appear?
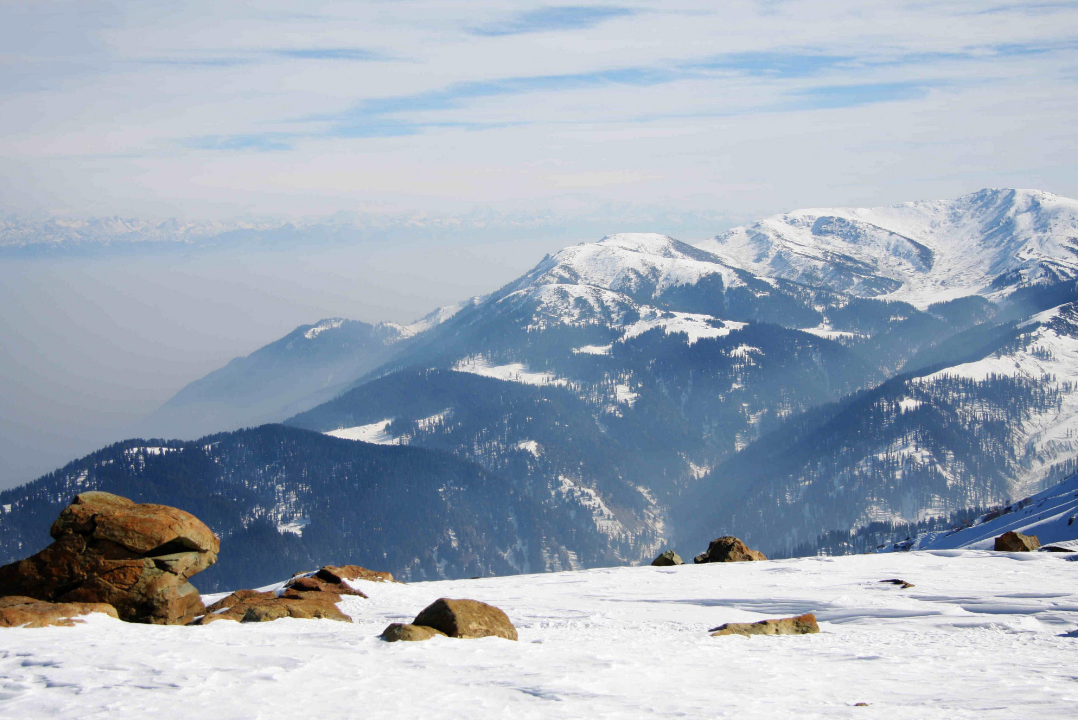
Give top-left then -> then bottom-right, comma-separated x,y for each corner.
0,425 -> 543,592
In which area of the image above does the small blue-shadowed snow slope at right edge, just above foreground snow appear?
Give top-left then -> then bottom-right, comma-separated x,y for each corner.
909,475 -> 1078,551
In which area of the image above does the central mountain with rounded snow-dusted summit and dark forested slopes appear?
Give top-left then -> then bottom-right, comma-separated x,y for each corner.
288,234 -> 995,569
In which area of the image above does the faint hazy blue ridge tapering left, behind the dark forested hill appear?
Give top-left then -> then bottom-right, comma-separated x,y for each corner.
141,306 -> 459,438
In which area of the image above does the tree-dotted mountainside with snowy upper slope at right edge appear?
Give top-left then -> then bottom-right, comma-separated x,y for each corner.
680,302 -> 1078,553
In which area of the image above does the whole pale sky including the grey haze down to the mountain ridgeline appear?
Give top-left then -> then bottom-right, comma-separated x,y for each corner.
0,0 -> 1078,488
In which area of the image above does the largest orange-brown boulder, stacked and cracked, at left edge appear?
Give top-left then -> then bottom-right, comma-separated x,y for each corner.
0,491 -> 221,624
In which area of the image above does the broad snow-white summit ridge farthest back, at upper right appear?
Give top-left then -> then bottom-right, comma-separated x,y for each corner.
700,190 -> 1078,307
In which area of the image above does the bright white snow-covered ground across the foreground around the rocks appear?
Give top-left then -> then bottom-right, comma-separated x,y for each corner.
0,551 -> 1078,720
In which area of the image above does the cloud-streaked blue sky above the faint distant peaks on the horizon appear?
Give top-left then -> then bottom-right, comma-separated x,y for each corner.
0,0 -> 1078,220
